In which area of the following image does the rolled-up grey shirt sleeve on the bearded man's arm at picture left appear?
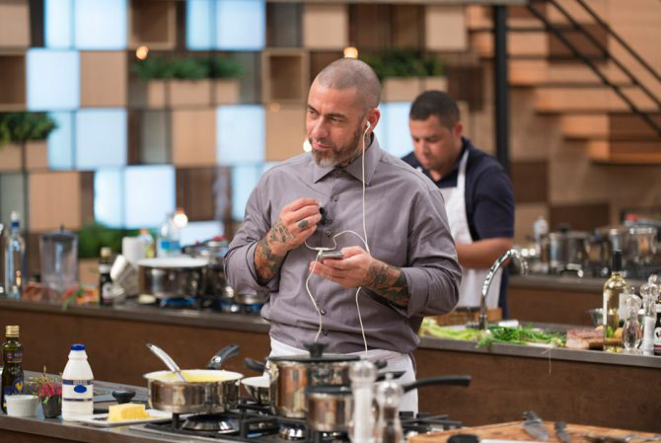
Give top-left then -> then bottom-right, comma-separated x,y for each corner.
225,183 -> 279,292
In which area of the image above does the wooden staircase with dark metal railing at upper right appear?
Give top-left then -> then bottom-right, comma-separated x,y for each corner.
468,0 -> 661,165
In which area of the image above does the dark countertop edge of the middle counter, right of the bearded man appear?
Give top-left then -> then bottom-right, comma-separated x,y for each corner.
419,337 -> 661,369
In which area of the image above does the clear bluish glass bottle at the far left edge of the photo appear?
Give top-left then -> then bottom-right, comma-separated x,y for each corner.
4,211 -> 27,300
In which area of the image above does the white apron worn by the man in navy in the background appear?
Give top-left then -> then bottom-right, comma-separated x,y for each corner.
434,150 -> 503,309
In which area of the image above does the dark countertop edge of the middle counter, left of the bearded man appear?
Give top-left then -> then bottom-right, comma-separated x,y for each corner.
0,299 -> 269,332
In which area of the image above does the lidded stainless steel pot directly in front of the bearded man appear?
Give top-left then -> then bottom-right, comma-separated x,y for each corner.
246,342 -> 360,418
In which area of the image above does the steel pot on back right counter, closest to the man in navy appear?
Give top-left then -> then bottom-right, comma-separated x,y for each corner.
548,230 -> 590,273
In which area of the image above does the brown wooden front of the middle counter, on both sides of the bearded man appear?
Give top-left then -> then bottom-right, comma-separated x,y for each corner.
0,300 -> 661,432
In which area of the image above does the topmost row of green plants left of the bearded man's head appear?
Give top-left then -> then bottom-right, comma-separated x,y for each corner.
131,55 -> 244,81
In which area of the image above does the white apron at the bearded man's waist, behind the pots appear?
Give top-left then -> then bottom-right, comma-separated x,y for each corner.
269,337 -> 418,414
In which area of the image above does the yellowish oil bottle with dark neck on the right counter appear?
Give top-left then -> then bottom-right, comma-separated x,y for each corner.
602,251 -> 628,352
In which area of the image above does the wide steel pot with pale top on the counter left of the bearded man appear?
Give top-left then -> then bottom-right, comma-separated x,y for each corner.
138,256 -> 207,299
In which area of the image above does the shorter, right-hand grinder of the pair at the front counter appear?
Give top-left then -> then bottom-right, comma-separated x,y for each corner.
376,374 -> 404,443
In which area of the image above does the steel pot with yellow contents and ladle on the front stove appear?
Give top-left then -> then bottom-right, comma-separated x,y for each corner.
144,345 -> 243,414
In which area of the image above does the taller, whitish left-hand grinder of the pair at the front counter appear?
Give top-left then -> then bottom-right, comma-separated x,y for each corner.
349,360 -> 377,443
